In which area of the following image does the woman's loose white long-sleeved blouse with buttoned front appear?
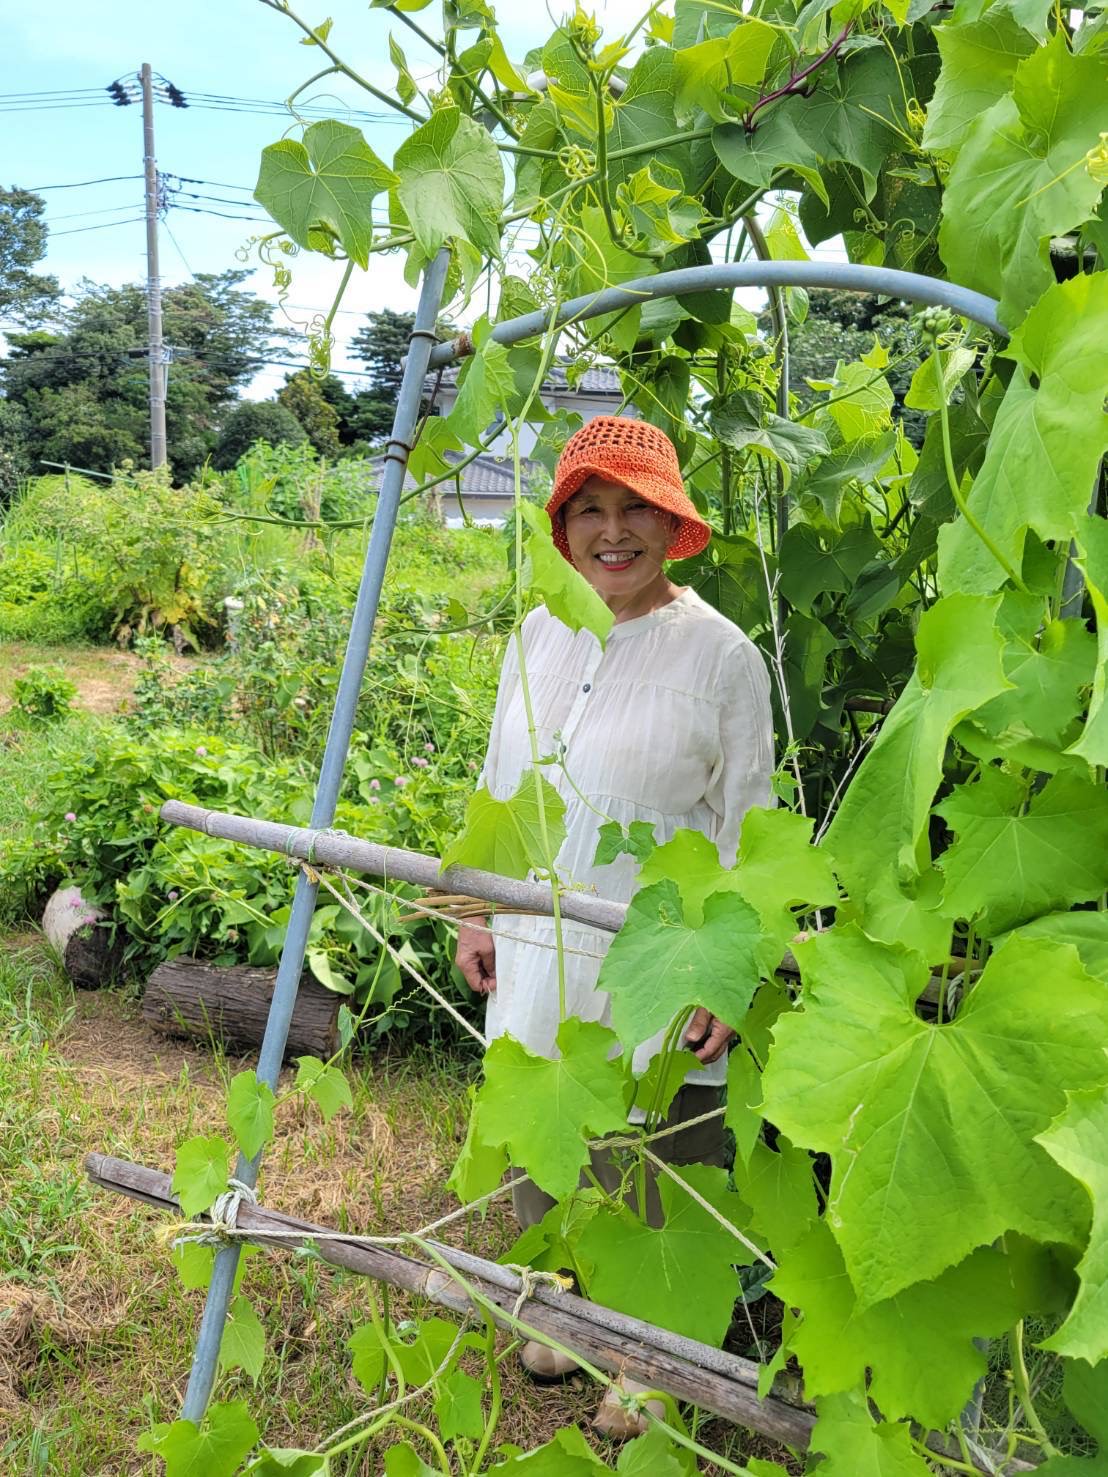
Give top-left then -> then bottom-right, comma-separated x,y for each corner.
482,589 -> 774,1086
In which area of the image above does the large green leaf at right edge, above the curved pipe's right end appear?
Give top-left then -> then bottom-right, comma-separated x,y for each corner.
940,32 -> 1108,325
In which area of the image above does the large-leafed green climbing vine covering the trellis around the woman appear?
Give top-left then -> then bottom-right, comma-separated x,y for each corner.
143,0 -> 1108,1477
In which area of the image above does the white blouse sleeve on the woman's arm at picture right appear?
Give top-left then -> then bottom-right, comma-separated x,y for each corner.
706,641 -> 774,867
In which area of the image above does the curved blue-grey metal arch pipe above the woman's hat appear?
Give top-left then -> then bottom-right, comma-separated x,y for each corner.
428,261 -> 1008,369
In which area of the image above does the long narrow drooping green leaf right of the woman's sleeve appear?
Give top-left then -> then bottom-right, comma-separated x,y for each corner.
824,595 -> 1008,904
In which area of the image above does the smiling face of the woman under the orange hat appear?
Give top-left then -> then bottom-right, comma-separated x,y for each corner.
563,477 -> 678,620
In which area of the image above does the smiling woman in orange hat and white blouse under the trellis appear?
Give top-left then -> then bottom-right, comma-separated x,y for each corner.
458,417 -> 773,1434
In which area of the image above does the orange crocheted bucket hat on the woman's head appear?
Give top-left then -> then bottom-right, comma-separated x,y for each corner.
547,415 -> 712,558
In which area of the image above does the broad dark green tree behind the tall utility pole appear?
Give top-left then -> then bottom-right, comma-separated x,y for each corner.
3,270 -> 286,480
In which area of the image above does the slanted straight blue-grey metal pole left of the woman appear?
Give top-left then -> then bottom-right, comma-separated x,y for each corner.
182,248 -> 451,1421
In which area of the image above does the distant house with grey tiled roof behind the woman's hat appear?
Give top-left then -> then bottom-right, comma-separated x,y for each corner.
374,365 -> 634,526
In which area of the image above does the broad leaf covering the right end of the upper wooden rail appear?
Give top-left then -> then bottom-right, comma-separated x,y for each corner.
598,874 -> 761,1050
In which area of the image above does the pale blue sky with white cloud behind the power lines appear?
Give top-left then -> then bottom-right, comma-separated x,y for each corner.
0,0 -> 646,396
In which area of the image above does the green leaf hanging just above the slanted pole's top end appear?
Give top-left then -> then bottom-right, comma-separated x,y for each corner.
393,108 -> 504,257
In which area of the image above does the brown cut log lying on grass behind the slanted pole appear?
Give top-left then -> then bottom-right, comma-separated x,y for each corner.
142,954 -> 340,1059
